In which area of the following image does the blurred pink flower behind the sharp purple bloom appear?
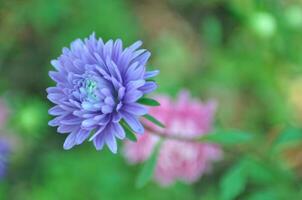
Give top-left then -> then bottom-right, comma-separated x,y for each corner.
124,92 -> 222,186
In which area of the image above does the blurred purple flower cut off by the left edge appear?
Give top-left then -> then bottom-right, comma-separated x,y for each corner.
0,138 -> 10,179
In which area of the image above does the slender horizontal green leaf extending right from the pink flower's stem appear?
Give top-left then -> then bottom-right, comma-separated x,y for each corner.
199,131 -> 253,145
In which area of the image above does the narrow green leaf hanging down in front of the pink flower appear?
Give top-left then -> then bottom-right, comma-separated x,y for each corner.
136,141 -> 161,188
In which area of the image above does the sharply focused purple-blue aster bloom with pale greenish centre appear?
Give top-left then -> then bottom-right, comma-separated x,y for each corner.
47,33 -> 159,153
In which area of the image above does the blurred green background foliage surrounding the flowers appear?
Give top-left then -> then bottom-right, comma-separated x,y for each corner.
0,0 -> 302,200
